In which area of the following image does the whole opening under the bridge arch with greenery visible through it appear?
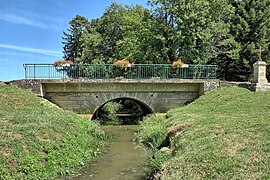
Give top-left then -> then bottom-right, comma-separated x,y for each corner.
92,98 -> 153,125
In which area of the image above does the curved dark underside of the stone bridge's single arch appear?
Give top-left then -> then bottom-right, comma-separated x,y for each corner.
91,96 -> 154,120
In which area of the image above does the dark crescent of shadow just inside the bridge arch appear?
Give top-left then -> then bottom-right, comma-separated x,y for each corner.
91,97 -> 154,123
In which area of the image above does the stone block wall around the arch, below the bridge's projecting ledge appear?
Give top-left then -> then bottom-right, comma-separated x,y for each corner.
46,92 -> 199,114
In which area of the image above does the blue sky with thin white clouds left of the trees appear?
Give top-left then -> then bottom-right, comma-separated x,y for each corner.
0,0 -> 147,81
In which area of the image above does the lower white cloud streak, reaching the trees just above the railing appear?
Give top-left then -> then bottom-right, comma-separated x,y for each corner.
0,44 -> 63,57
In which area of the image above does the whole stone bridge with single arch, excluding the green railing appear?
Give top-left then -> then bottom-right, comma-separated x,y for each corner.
10,79 -> 219,114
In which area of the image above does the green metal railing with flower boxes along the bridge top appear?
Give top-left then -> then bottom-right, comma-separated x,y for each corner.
23,64 -> 217,79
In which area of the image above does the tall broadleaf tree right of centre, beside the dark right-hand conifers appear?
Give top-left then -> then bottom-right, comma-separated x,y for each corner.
149,0 -> 232,64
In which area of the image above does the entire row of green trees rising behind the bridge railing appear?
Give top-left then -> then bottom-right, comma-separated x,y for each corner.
64,0 -> 270,81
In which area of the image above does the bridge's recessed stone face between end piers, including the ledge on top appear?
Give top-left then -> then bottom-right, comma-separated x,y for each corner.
42,81 -> 204,113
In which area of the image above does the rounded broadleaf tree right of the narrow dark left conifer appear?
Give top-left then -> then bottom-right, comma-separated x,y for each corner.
76,3 -> 161,63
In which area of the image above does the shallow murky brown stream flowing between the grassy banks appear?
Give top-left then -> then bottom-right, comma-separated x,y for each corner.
74,125 -> 146,180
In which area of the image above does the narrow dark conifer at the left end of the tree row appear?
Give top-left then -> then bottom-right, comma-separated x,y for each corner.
62,15 -> 89,61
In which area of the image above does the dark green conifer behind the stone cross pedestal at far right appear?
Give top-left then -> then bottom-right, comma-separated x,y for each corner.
227,0 -> 270,80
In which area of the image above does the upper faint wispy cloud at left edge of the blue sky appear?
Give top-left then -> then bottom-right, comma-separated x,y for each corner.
0,14 -> 49,29
